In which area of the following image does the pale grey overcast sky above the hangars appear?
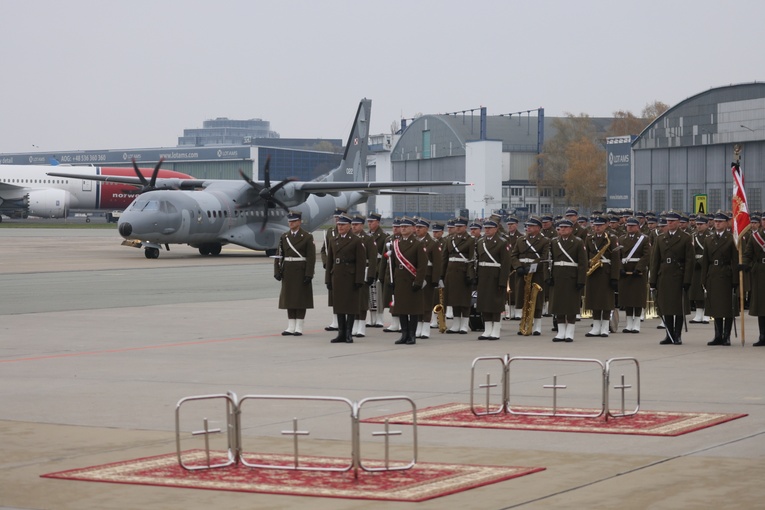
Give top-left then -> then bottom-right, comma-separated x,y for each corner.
0,0 -> 765,152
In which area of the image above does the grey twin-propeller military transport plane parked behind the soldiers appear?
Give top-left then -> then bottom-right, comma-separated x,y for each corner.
50,99 -> 466,259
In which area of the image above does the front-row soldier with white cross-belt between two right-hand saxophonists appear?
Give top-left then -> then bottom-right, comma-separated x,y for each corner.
548,219 -> 588,342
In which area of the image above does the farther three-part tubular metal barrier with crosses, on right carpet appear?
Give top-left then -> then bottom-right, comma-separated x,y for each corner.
470,354 -> 640,420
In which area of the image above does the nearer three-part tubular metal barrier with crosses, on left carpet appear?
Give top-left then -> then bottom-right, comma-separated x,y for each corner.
175,392 -> 417,477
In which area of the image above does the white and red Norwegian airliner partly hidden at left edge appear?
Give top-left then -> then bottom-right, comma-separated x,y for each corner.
0,161 -> 191,221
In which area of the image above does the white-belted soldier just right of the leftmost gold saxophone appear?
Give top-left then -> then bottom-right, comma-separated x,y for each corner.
444,217 -> 475,335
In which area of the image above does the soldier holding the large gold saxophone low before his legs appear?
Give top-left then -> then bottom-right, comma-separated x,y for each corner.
510,217 -> 550,336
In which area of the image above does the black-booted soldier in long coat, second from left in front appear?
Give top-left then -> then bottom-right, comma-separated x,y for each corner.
324,214 -> 367,344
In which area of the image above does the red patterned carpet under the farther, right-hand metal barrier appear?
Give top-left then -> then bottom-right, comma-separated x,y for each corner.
362,404 -> 746,436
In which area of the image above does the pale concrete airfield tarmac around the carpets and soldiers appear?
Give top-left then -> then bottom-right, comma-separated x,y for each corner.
0,229 -> 765,510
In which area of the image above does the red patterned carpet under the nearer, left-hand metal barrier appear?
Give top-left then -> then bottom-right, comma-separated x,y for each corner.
42,450 -> 545,502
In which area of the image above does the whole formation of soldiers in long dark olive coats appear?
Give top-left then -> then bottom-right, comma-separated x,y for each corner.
274,209 -> 765,346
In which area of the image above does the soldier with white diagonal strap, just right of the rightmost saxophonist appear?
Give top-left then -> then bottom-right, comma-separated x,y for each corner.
619,218 -> 651,333
